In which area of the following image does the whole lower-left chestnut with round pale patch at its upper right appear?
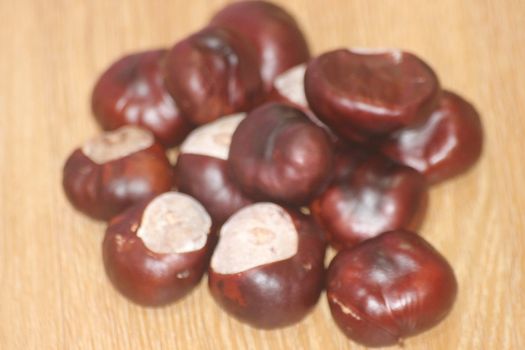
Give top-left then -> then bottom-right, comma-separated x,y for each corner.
102,192 -> 214,306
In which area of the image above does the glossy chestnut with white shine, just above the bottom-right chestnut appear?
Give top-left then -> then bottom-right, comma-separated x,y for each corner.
310,149 -> 428,248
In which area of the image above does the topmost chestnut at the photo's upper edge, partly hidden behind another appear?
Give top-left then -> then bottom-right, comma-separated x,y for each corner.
211,1 -> 310,91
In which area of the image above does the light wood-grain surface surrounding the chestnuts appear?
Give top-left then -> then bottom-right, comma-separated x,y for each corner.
0,0 -> 525,350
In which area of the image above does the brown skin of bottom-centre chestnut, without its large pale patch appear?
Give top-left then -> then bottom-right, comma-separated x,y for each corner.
208,210 -> 326,329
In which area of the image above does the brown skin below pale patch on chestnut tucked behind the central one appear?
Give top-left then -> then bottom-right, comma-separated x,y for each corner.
175,153 -> 253,225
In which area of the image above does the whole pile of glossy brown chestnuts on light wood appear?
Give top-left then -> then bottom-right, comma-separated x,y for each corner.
63,1 -> 482,346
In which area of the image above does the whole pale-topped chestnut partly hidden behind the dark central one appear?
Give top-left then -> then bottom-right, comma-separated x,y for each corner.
175,113 -> 252,225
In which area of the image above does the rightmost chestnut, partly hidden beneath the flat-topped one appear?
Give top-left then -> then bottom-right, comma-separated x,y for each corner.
381,91 -> 483,183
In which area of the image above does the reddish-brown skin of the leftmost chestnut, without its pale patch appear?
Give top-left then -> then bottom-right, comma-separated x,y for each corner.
62,142 -> 174,220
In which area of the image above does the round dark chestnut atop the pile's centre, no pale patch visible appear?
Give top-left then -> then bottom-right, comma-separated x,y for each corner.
228,103 -> 333,205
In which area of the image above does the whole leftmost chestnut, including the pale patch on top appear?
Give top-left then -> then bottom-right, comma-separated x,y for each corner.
63,126 -> 173,220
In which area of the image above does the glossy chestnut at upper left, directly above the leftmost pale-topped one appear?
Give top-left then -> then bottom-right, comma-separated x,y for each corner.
91,50 -> 191,147
